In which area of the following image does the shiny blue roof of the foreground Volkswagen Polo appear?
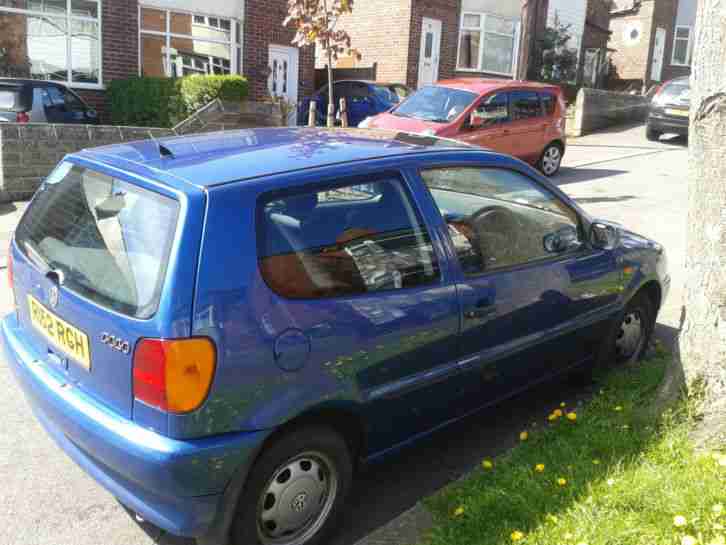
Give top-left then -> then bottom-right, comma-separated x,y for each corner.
74,127 -> 481,187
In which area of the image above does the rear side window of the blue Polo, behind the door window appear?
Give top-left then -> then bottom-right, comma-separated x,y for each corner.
257,176 -> 440,299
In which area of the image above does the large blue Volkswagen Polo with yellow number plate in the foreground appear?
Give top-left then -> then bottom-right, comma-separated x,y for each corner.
1,128 -> 669,545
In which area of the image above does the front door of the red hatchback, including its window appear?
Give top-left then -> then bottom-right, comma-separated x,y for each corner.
456,92 -> 514,154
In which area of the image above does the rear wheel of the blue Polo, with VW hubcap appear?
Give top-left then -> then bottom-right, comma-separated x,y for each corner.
231,426 -> 353,545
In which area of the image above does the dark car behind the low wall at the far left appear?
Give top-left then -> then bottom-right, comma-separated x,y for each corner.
0,78 -> 98,125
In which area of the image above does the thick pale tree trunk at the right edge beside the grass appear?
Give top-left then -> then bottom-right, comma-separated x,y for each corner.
680,0 -> 726,444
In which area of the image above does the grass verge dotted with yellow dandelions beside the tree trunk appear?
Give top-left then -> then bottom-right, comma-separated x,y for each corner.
426,352 -> 726,545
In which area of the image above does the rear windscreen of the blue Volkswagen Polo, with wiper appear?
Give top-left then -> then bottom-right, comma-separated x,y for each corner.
16,162 -> 179,319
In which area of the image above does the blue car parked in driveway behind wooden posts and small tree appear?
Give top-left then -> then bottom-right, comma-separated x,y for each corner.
298,80 -> 411,127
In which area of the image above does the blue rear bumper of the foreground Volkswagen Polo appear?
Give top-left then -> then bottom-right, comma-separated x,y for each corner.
0,314 -> 268,537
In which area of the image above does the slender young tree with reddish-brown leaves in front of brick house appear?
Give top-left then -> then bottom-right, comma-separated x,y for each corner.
283,0 -> 360,125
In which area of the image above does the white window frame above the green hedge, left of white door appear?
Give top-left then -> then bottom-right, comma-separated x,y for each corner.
138,3 -> 244,77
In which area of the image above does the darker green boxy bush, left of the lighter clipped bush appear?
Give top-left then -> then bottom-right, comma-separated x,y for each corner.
108,77 -> 184,127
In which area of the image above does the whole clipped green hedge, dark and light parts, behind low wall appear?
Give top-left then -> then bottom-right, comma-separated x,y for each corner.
108,75 -> 249,127
